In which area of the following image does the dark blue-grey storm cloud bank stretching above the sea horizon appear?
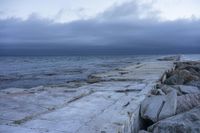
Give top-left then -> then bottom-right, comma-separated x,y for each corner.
0,3 -> 200,55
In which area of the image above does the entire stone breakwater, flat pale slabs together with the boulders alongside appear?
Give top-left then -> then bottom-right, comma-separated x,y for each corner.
0,56 -> 200,133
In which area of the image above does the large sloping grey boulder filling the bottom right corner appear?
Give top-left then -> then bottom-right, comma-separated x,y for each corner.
148,106 -> 200,133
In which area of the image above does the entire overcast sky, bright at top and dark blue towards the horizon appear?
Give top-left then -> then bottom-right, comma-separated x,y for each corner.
0,0 -> 200,55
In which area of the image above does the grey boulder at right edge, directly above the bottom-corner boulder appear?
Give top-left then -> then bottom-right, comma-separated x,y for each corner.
176,94 -> 200,114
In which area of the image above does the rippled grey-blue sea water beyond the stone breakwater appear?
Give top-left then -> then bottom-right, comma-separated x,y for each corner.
0,55 -> 200,89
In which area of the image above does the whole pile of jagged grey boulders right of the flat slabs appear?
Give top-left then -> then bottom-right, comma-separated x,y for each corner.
139,59 -> 200,133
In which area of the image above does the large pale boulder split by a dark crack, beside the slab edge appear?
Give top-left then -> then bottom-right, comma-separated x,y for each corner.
140,91 -> 177,122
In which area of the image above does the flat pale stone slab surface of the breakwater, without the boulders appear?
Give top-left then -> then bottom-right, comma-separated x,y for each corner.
0,61 -> 173,133
